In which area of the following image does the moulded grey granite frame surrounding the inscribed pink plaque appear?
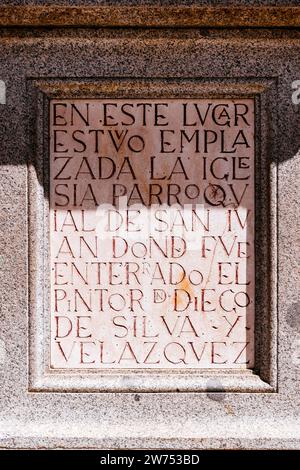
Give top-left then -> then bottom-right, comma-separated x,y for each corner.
27,77 -> 277,392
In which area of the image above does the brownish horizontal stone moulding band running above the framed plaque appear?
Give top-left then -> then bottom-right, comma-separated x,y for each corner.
0,2 -> 300,28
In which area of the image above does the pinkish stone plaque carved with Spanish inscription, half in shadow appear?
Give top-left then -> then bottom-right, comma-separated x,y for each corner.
50,99 -> 255,369
